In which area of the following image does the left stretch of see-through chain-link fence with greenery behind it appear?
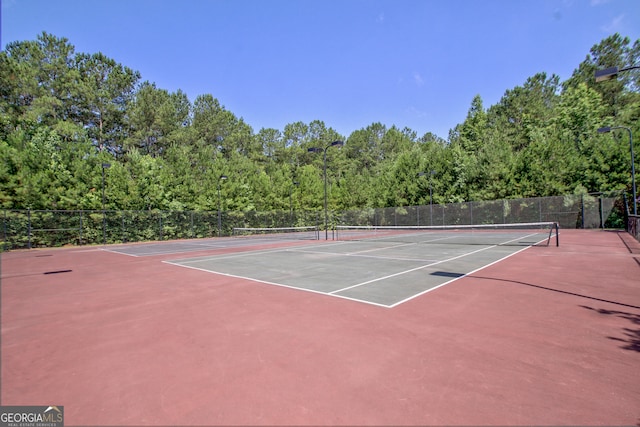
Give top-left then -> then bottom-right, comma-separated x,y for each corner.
2,210 -> 321,250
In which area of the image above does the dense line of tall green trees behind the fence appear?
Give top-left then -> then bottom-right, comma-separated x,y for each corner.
0,32 -> 640,216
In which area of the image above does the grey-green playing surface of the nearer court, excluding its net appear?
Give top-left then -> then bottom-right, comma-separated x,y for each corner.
167,241 -> 544,307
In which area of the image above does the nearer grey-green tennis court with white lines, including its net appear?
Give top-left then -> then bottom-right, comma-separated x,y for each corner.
167,223 -> 558,307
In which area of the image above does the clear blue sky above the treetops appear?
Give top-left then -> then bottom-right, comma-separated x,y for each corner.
1,0 -> 640,138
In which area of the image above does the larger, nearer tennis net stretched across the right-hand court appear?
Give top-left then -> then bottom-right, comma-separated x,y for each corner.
336,222 -> 560,246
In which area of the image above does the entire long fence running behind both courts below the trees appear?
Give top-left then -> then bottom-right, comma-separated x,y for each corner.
1,192 -> 638,250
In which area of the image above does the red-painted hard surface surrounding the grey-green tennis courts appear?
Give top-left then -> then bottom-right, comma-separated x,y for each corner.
0,230 -> 640,426
